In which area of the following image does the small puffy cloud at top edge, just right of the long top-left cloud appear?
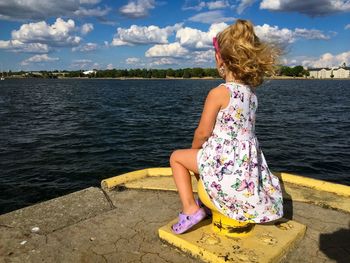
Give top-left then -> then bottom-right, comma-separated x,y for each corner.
119,0 -> 155,18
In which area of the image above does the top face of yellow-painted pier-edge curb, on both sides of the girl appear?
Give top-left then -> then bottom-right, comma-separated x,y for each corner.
101,167 -> 350,197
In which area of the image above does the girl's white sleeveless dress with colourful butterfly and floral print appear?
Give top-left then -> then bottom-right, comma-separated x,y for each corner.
197,82 -> 283,223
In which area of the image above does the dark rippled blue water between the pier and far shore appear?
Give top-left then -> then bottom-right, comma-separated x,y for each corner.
0,79 -> 350,214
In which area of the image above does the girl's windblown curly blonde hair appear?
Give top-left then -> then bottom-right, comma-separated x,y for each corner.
217,19 -> 281,87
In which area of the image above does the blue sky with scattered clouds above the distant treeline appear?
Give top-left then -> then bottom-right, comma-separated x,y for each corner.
0,0 -> 350,71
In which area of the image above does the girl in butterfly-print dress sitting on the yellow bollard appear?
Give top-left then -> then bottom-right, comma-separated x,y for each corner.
170,20 -> 283,234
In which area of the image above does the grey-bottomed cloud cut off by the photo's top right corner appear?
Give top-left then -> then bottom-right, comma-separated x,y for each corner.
260,0 -> 350,16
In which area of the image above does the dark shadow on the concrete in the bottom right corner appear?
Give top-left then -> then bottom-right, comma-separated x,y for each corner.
320,224 -> 350,263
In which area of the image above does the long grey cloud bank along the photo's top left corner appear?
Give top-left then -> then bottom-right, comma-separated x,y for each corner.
0,0 -> 110,21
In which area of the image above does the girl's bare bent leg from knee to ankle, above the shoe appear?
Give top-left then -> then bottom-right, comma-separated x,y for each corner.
170,149 -> 199,215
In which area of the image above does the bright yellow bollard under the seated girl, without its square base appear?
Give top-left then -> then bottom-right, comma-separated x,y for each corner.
197,180 -> 255,237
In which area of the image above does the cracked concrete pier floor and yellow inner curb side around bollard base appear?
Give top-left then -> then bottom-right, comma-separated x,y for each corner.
0,168 -> 350,263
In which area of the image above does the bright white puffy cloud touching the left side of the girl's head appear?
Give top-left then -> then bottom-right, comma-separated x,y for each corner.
176,23 -> 228,49
